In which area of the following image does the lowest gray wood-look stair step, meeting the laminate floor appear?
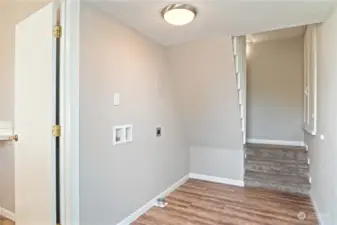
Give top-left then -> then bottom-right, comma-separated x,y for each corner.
245,172 -> 310,194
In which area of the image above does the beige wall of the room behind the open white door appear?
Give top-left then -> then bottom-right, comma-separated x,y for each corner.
0,0 -> 46,212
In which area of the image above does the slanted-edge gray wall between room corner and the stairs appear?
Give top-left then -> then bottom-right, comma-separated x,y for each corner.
167,36 -> 243,180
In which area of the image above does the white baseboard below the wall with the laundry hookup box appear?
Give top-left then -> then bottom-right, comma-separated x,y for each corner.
117,174 -> 189,225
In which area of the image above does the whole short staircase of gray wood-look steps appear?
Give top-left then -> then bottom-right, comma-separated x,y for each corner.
245,144 -> 310,195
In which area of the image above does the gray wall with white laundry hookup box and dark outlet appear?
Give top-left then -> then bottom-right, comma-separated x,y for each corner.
80,4 -> 189,225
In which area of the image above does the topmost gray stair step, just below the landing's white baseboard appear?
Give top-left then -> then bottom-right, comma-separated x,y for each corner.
246,148 -> 308,161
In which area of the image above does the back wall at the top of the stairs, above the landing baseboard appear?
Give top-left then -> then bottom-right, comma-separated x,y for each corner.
247,37 -> 304,141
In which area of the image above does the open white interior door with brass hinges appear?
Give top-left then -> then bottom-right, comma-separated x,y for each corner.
15,4 -> 56,225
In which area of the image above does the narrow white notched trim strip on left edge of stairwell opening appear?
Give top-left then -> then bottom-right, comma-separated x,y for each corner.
233,36 -> 247,144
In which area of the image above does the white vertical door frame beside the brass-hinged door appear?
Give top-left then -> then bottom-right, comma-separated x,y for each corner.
60,0 -> 80,225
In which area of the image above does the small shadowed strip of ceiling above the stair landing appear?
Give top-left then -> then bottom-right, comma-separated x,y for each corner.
247,26 -> 306,44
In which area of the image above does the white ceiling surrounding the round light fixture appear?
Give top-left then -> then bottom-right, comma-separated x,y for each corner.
89,0 -> 335,45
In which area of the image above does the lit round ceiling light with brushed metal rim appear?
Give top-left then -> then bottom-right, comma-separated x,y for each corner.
161,4 -> 197,26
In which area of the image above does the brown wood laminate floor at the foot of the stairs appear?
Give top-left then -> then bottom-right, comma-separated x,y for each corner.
133,179 -> 318,225
